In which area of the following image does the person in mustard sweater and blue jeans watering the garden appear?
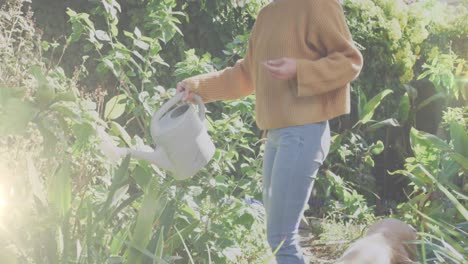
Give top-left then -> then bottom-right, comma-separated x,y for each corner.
177,0 -> 362,264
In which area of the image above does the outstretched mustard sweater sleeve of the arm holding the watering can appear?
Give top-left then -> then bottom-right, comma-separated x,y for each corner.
183,39 -> 254,103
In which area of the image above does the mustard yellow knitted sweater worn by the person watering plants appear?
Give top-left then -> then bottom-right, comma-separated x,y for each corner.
184,0 -> 363,129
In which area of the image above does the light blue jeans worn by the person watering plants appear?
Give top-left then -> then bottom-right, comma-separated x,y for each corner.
263,122 -> 330,264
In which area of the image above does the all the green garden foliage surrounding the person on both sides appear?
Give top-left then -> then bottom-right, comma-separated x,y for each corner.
0,0 -> 468,263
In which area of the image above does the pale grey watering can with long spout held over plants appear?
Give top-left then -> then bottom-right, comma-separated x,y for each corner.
98,93 -> 215,180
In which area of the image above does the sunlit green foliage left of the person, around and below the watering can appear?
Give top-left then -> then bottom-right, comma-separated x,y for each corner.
0,1 -> 268,263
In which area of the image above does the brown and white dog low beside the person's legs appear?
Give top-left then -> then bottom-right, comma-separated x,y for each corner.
336,218 -> 416,264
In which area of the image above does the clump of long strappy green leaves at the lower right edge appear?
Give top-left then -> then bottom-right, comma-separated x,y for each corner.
395,122 -> 468,263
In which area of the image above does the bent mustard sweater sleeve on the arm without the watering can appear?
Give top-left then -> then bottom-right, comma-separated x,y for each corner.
297,0 -> 363,96
